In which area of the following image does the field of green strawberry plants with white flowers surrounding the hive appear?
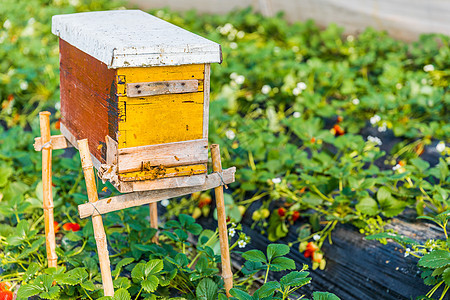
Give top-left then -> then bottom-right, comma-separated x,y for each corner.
0,0 -> 450,299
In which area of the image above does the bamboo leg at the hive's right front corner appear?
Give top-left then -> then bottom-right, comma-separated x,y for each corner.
211,144 -> 233,297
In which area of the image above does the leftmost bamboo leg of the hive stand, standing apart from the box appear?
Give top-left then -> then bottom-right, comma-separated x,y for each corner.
39,111 -> 58,267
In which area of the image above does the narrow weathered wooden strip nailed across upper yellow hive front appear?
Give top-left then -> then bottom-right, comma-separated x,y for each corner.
127,79 -> 198,97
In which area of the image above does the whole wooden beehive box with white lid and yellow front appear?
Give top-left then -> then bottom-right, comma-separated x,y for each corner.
52,10 -> 222,192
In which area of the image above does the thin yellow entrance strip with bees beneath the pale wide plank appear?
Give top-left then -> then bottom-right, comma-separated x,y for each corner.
119,164 -> 208,182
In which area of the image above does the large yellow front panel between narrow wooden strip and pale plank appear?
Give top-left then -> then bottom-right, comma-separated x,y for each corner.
119,92 -> 203,149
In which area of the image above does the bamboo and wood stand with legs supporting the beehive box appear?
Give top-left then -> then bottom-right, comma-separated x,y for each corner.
34,112 -> 236,297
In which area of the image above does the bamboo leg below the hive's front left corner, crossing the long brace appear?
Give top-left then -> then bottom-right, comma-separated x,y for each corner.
78,139 -> 114,296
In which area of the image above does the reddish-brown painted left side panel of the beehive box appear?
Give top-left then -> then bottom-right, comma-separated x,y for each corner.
60,40 -> 118,163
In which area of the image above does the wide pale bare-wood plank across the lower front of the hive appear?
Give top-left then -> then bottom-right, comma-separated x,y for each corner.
118,139 -> 208,173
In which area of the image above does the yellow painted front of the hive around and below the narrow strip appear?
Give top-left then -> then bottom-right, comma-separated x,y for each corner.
117,65 -> 204,148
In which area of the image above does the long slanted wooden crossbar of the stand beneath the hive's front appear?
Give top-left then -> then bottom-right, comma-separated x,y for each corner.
78,167 -> 236,218
